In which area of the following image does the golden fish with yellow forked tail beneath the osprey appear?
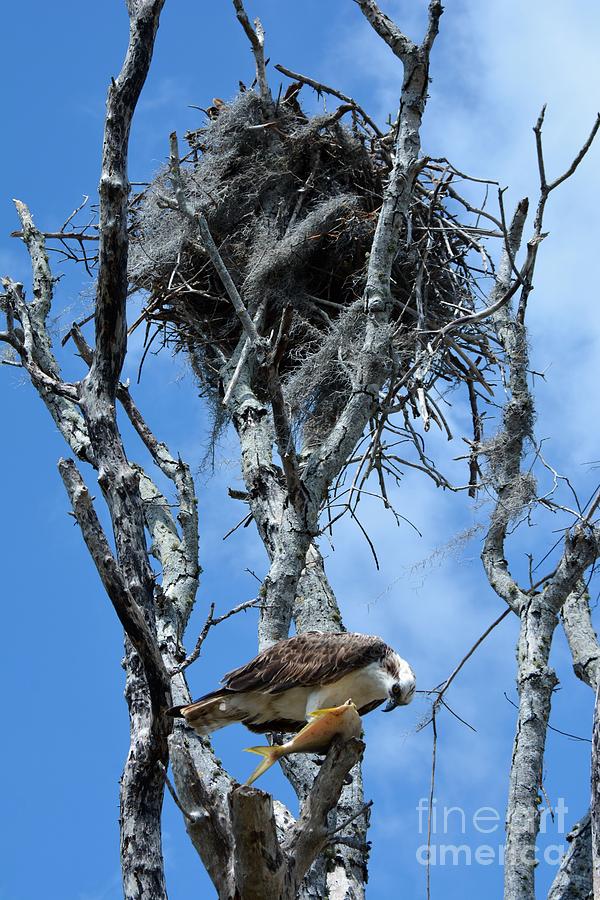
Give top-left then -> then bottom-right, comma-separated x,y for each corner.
245,700 -> 362,786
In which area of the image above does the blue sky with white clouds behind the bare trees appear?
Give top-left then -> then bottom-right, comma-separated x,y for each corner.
0,0 -> 600,900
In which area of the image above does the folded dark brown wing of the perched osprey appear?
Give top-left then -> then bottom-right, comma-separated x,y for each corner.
223,631 -> 389,694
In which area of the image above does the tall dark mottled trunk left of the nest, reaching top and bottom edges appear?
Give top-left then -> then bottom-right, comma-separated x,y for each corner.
80,0 -> 170,900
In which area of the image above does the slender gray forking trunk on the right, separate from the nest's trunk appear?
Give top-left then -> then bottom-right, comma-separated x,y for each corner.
482,123 -> 600,900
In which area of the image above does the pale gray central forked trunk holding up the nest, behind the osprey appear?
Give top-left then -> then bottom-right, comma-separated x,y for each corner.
216,3 -> 441,900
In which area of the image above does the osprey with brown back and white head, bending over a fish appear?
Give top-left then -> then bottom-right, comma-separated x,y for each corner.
171,631 -> 415,735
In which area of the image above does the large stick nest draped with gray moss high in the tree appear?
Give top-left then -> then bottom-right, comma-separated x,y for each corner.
129,85 -> 496,454
